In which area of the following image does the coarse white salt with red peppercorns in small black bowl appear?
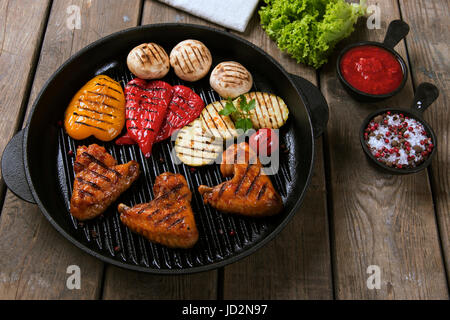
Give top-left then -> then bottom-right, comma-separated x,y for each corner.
364,111 -> 434,169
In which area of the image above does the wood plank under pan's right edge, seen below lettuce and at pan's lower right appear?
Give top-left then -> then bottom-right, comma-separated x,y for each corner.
224,14 -> 333,299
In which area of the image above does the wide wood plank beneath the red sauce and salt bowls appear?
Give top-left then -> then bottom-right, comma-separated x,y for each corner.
320,0 -> 448,299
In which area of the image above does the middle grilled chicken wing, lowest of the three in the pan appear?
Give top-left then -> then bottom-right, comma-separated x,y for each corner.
118,172 -> 198,248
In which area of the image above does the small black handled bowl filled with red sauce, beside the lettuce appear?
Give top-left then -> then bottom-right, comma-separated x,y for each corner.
336,20 -> 409,102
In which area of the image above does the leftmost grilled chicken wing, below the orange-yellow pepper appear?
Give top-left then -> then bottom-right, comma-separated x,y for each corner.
70,144 -> 139,220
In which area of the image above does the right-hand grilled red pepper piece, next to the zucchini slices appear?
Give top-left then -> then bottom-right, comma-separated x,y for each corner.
156,85 -> 205,142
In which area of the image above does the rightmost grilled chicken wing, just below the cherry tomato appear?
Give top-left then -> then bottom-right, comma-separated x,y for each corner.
198,142 -> 283,217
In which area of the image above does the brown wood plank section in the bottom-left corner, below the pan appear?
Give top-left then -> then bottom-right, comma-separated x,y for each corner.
0,191 -> 103,300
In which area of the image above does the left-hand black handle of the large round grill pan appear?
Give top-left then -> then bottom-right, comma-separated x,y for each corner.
2,130 -> 36,203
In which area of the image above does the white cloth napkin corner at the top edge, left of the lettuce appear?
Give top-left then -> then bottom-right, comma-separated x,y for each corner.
159,0 -> 258,32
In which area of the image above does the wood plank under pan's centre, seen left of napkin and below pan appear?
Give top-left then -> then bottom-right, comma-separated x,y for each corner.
103,1 -> 217,299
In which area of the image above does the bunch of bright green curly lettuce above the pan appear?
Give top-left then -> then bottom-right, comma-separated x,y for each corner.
259,0 -> 366,68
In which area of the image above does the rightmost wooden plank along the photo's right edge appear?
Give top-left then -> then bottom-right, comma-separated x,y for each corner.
400,0 -> 450,285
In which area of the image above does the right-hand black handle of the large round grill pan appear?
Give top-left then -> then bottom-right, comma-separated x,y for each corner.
290,74 -> 329,139
